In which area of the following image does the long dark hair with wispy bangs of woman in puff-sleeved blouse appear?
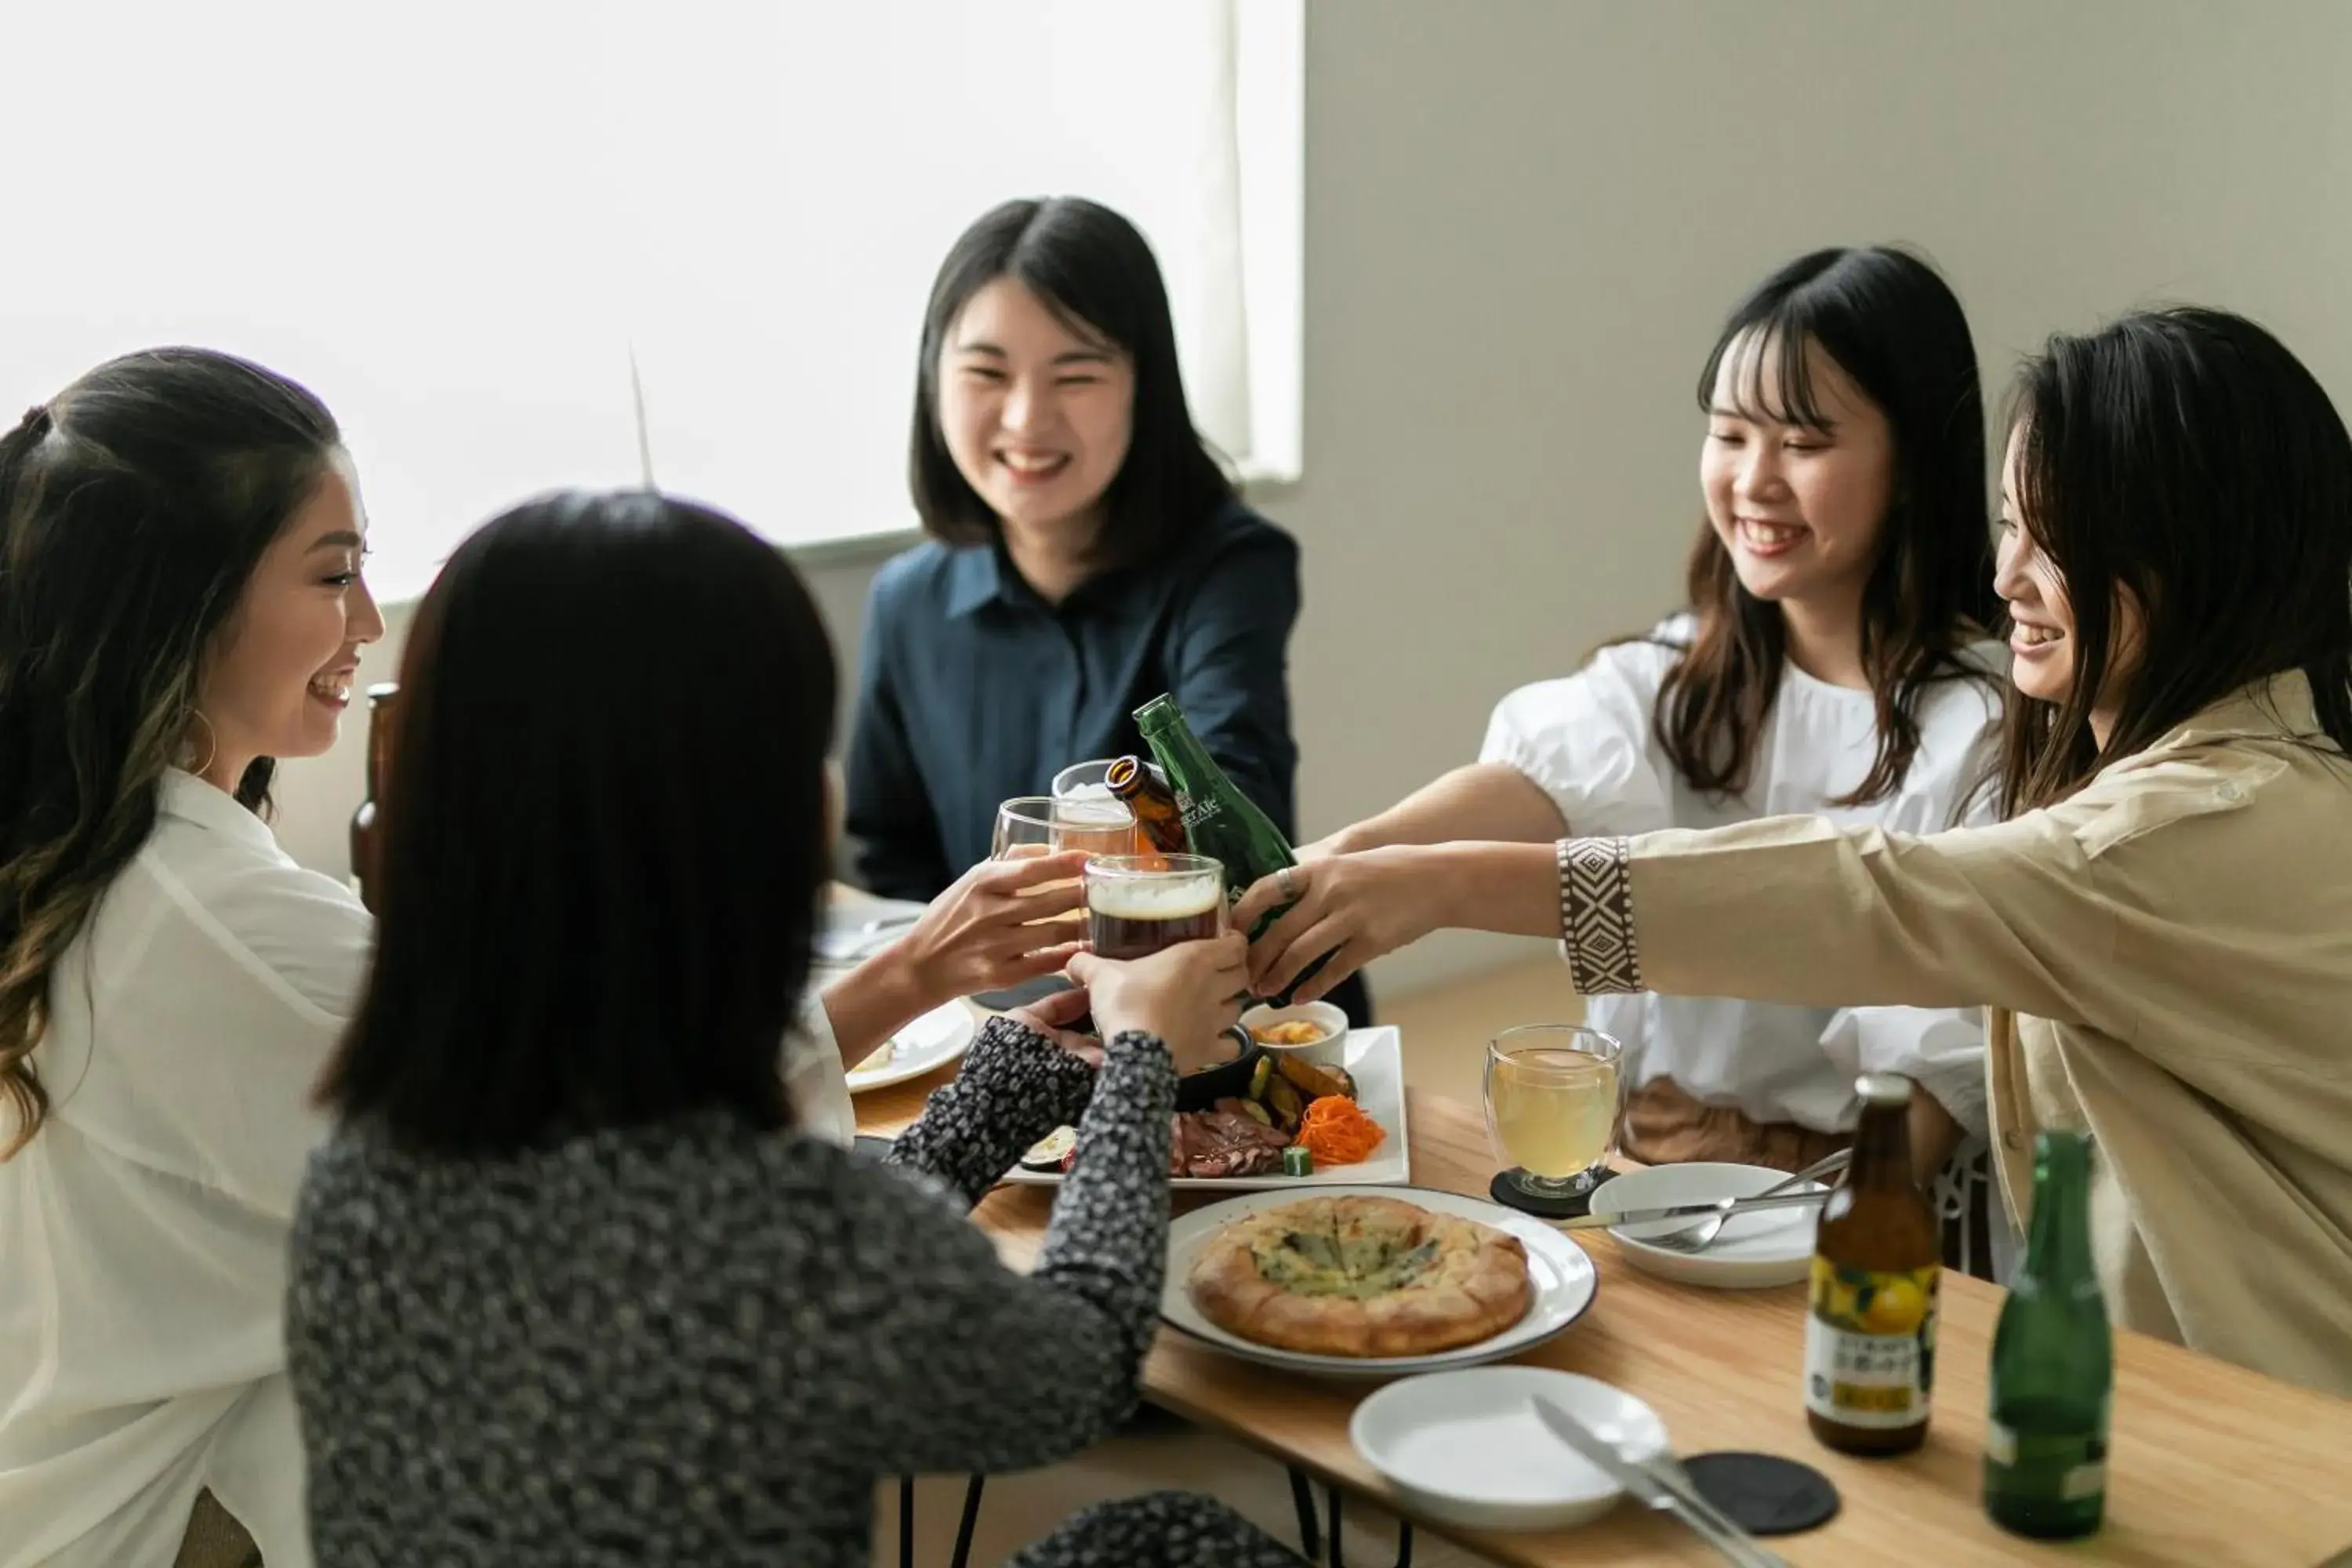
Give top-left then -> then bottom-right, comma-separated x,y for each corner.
1651,247 -> 1999,806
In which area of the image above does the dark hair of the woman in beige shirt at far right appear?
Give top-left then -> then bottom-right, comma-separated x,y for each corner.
2002,310 -> 2352,813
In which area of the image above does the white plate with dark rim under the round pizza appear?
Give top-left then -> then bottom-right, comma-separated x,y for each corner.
1160,1187 -> 1599,1377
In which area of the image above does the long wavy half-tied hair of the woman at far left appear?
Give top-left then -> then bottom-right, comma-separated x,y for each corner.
0,348 -> 341,1159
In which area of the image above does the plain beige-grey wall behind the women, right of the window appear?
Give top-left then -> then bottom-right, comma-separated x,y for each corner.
262,0 -> 2352,987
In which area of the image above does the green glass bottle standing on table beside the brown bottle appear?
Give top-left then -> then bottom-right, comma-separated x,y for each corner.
1985,1131 -> 2114,1540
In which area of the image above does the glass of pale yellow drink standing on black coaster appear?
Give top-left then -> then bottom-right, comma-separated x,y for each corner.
1484,1022 -> 1625,1203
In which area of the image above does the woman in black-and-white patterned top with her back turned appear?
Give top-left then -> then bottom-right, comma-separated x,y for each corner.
287,494 -> 1298,1568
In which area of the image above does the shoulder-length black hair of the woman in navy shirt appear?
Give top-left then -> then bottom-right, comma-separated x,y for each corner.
908,195 -> 1235,567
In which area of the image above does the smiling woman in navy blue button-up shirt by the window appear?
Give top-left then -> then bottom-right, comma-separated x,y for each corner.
849,198 -> 1364,1013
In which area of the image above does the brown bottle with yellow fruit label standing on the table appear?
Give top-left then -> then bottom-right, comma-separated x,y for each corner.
1804,1072 -> 1943,1453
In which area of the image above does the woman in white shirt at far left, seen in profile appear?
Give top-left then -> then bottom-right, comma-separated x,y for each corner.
0,348 -> 1068,1568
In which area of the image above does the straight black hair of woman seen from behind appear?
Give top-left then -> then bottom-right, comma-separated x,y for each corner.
320,492 -> 835,1154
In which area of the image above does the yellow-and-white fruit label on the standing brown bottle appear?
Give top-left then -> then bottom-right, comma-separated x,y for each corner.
1804,1258 -> 1943,1429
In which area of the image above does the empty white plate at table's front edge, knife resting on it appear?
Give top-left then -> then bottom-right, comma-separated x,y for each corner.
1348,1366 -> 1670,1530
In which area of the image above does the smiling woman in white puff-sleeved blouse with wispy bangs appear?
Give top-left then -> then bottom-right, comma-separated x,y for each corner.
1308,249 -> 1999,1253
